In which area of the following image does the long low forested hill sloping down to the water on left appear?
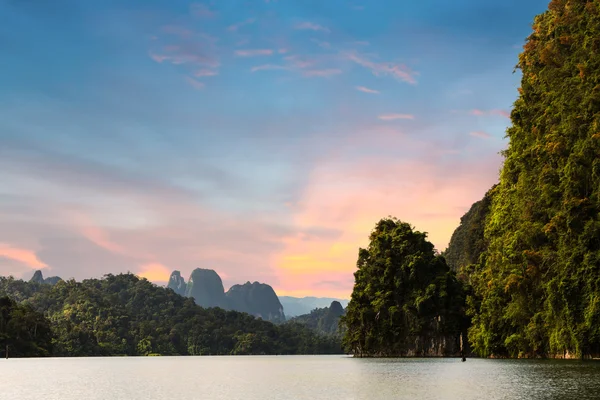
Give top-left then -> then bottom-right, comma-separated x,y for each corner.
0,274 -> 341,356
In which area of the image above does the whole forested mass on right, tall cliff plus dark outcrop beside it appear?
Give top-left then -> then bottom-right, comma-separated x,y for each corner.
344,0 -> 600,358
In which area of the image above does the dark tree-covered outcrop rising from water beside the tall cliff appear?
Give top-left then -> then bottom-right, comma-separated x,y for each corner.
342,218 -> 465,356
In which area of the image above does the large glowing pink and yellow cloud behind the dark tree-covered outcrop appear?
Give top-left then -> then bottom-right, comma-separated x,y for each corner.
272,127 -> 501,297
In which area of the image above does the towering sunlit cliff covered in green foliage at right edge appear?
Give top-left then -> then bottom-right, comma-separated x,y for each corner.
469,0 -> 600,357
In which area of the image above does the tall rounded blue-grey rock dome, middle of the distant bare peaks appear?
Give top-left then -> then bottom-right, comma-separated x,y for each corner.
185,268 -> 228,309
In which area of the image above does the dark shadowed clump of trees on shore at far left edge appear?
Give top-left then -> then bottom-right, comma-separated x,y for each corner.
0,297 -> 52,357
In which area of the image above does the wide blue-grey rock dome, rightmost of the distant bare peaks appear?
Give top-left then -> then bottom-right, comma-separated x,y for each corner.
226,282 -> 285,322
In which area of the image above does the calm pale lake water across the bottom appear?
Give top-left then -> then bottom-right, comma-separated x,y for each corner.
0,356 -> 600,400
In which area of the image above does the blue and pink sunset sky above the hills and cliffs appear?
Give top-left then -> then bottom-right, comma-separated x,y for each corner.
0,0 -> 547,298
